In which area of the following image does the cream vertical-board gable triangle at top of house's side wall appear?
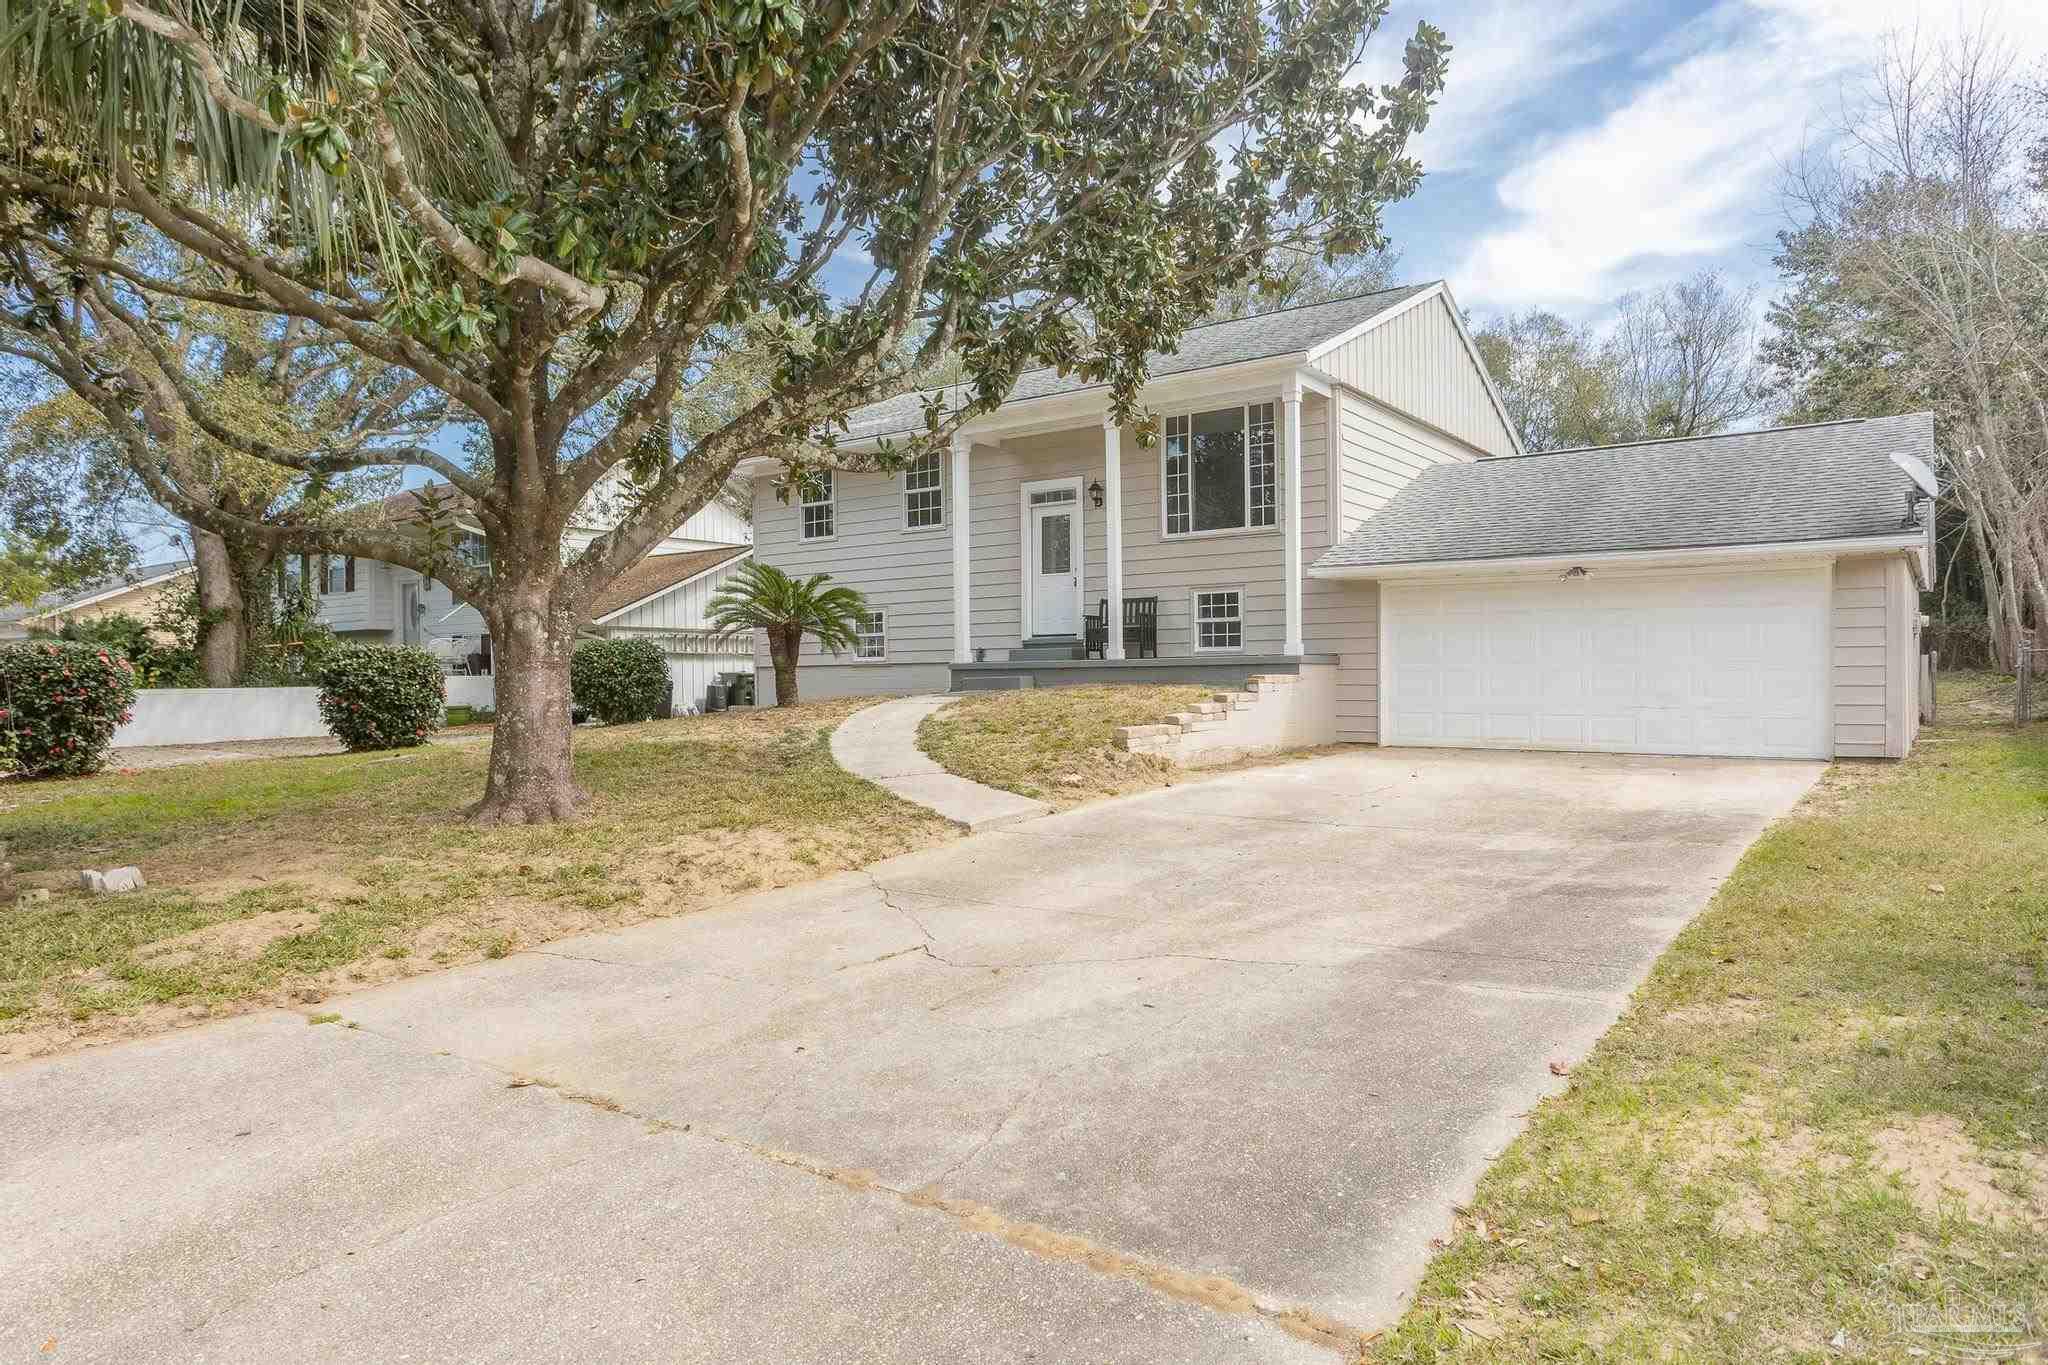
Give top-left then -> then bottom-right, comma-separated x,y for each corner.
1315,293 -> 1516,454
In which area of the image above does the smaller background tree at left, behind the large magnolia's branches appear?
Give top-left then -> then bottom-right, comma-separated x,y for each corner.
0,237 -> 449,688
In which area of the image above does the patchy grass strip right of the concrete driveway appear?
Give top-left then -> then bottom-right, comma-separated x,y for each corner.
1372,677 -> 2048,1361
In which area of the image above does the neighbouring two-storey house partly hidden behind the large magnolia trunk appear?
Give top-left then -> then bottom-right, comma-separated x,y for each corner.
303,485 -> 754,710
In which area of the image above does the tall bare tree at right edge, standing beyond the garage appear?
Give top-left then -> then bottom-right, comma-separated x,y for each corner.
1778,33 -> 2048,667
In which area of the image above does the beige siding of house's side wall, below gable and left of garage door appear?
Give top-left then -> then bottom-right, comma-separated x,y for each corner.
1303,385 -> 1481,743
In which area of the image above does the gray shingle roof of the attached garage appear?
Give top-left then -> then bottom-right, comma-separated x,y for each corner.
1315,413 -> 1935,569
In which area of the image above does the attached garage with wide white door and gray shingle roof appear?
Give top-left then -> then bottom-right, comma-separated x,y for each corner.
1311,413 -> 1933,759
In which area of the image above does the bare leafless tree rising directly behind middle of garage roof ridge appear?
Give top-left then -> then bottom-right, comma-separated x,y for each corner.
1606,270 -> 1763,436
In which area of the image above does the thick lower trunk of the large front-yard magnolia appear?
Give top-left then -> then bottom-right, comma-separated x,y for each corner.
469,583 -> 586,825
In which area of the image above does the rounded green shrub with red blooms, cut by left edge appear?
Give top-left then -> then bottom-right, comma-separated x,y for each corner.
0,641 -> 135,778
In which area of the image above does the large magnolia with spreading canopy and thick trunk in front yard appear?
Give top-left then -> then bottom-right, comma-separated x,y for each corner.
0,0 -> 1446,821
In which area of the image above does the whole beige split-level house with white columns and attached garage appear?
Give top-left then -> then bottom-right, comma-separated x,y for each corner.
743,282 -> 1933,757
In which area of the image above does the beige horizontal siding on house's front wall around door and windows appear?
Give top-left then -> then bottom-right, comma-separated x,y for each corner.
754,395 -> 1364,698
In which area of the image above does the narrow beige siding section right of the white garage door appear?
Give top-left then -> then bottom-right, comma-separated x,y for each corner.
1831,555 -> 1921,759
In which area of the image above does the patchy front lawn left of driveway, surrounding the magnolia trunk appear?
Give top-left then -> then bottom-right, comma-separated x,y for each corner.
0,702 -> 956,1058
